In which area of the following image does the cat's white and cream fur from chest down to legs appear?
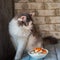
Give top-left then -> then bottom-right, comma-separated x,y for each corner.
9,18 -> 42,60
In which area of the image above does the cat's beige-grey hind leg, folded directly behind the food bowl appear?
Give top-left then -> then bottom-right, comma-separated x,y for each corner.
26,35 -> 43,51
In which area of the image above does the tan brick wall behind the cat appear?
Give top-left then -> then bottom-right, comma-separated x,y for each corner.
15,0 -> 60,38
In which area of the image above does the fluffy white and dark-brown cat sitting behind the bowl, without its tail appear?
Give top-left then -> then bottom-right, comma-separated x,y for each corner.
9,13 -> 43,60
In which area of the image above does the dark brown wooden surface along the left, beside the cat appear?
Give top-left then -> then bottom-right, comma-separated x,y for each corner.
0,0 -> 15,60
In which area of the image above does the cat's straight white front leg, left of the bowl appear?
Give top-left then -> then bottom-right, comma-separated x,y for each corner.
14,40 -> 27,60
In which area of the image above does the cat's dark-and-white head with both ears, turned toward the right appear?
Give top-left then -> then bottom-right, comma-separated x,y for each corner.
18,13 -> 34,30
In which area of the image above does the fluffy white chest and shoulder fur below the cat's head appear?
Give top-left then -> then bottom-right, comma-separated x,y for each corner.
9,19 -> 31,37
